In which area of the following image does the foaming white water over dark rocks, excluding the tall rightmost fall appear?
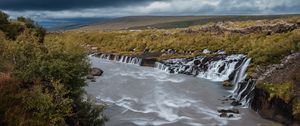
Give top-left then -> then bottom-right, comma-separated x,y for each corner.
156,55 -> 246,82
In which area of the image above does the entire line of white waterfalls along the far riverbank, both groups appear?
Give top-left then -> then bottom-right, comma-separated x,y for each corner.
95,54 -> 255,107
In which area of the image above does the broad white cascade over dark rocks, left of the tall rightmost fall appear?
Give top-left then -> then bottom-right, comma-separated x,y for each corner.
155,54 -> 246,82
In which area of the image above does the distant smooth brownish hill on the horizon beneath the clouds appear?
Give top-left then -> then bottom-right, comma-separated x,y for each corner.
68,15 -> 295,31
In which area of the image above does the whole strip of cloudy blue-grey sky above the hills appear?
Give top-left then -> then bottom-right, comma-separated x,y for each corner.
0,0 -> 300,27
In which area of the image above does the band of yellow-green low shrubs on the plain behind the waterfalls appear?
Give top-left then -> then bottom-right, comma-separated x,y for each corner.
47,17 -> 300,68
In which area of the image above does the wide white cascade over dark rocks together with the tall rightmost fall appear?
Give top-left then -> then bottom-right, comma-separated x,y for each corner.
156,55 -> 255,107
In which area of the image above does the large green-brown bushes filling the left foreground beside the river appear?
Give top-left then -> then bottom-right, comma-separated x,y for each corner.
0,12 -> 106,126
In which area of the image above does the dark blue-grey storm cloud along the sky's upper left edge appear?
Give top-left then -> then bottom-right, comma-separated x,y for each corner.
0,0 -> 164,11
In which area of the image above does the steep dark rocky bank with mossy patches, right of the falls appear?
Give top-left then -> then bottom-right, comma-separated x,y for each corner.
251,52 -> 300,126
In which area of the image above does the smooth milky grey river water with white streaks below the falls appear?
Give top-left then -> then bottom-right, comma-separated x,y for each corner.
86,57 -> 272,126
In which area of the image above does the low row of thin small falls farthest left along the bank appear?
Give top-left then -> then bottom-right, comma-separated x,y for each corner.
94,53 -> 142,65
